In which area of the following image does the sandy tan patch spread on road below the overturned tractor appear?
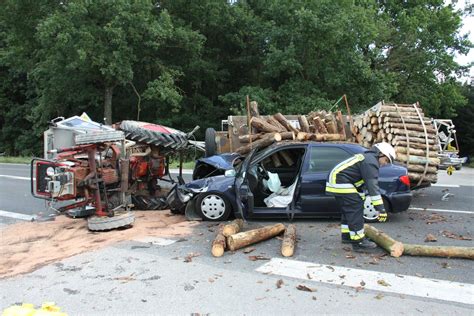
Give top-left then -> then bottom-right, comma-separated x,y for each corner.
0,211 -> 197,278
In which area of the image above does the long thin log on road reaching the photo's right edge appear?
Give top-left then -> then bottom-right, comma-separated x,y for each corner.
403,244 -> 474,260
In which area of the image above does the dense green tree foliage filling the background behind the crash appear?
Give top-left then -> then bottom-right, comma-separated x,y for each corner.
0,0 -> 473,154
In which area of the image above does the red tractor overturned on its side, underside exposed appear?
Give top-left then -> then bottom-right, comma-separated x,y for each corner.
31,116 -> 199,231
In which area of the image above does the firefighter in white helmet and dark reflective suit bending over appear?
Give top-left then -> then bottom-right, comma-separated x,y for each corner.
326,142 -> 396,251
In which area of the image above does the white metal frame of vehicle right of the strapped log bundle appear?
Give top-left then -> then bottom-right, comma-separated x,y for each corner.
433,119 -> 467,170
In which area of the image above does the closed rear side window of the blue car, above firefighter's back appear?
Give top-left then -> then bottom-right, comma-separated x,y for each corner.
308,146 -> 351,172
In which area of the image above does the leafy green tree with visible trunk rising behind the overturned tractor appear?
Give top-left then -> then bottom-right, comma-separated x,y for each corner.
33,0 -> 201,123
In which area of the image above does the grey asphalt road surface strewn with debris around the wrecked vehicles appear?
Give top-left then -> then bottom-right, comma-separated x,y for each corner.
0,165 -> 474,315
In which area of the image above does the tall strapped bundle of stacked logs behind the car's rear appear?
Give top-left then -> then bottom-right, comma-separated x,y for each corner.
353,102 -> 440,187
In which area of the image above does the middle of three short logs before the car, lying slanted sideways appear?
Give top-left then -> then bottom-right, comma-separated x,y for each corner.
227,223 -> 285,251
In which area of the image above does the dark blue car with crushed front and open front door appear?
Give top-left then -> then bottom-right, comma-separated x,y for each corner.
167,141 -> 412,222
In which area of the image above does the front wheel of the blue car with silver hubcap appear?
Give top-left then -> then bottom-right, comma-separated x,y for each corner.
196,192 -> 232,222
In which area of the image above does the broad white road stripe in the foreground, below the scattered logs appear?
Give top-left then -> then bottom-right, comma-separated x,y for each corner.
256,258 -> 474,304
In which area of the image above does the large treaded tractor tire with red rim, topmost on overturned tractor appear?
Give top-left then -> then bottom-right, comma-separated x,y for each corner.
120,121 -> 188,149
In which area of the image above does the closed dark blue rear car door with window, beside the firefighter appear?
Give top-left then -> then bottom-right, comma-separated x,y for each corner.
299,144 -> 352,215
